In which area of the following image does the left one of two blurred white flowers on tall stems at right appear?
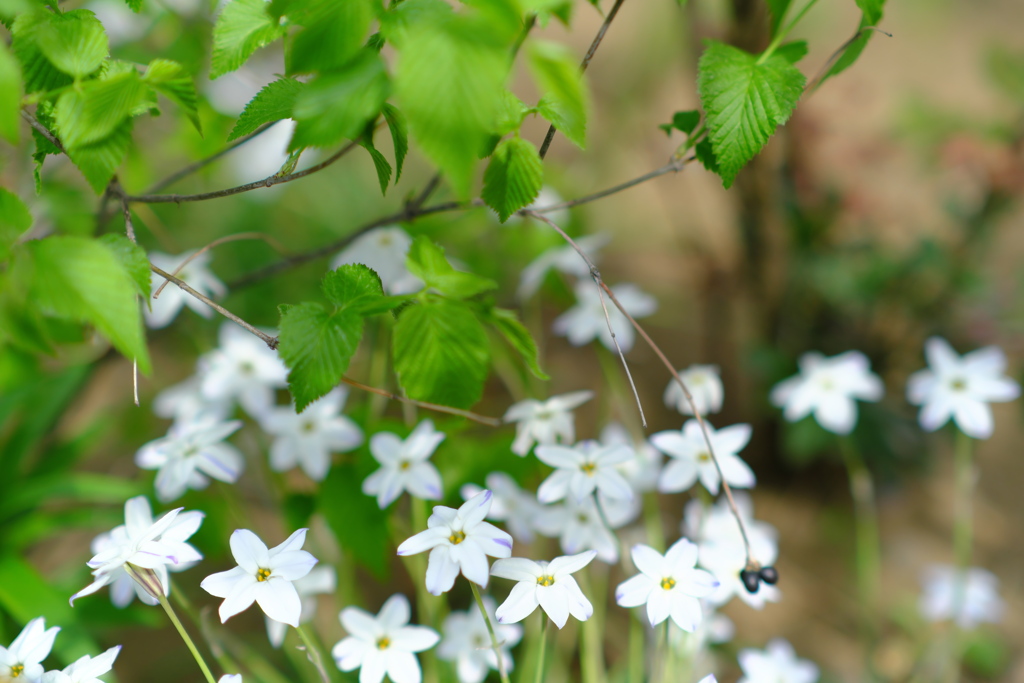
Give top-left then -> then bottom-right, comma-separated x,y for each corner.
771,351 -> 885,434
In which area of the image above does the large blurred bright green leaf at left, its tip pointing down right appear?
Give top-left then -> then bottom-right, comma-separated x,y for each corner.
26,237 -> 150,374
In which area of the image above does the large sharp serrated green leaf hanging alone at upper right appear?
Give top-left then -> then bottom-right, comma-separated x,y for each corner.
697,41 -> 805,187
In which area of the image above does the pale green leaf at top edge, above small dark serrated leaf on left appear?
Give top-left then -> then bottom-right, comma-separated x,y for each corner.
210,0 -> 285,79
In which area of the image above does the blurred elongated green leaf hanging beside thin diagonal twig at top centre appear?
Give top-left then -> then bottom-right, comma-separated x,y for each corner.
529,41 -> 590,147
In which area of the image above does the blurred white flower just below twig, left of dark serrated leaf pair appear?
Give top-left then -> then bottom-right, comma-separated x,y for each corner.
199,323 -> 288,417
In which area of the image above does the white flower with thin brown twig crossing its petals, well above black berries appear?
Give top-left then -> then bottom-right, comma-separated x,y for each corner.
650,420 -> 756,496
